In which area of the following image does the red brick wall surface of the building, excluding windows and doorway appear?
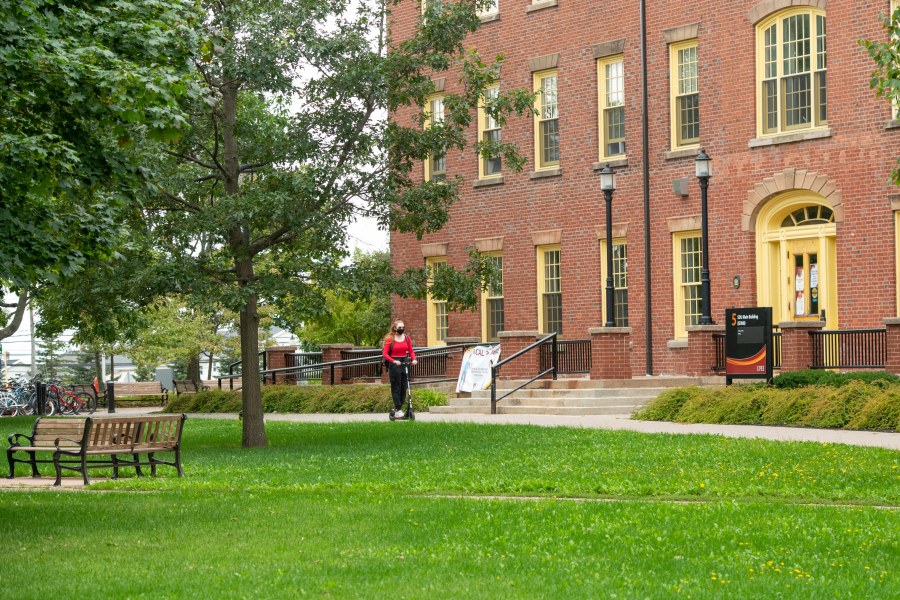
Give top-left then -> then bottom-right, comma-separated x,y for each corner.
391,0 -> 900,374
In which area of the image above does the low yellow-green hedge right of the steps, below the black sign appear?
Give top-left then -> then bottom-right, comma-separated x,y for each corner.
634,380 -> 900,431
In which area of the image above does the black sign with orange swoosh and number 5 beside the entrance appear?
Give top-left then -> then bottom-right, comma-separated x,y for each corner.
725,306 -> 773,383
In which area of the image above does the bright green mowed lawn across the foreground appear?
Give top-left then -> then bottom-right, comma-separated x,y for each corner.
0,419 -> 900,598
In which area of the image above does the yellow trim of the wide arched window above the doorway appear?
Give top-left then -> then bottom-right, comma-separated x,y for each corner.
754,6 -> 828,138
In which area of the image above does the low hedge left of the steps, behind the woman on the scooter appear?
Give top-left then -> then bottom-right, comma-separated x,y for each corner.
167,384 -> 447,413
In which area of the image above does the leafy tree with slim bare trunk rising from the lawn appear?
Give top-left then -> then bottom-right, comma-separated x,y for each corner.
143,0 -> 533,446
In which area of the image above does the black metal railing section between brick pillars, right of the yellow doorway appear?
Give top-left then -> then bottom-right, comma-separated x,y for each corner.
809,329 -> 887,369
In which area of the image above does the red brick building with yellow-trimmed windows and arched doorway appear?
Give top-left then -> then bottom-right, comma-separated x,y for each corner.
391,0 -> 900,375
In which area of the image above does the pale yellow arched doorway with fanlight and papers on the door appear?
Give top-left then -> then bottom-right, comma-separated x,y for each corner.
756,190 -> 838,329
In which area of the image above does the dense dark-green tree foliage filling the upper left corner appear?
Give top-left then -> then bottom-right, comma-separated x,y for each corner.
0,0 -> 200,339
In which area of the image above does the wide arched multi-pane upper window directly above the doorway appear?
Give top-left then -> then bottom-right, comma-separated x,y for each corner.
757,7 -> 828,135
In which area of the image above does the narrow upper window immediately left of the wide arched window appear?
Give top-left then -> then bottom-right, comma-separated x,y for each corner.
669,40 -> 700,150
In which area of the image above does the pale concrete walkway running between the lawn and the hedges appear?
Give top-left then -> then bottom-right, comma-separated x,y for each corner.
97,408 -> 900,450
